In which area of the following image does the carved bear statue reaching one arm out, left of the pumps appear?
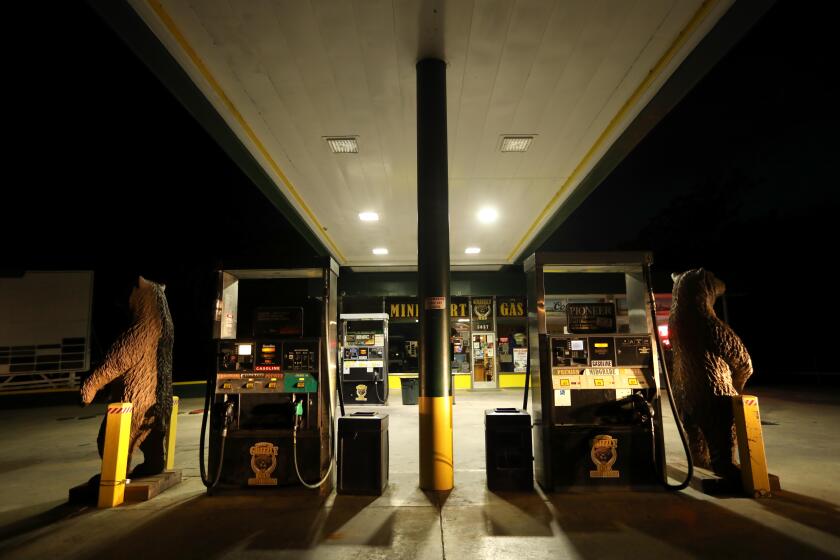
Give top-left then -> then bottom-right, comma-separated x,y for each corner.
81,276 -> 174,477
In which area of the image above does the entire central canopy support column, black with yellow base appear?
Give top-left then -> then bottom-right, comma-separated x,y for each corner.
417,59 -> 454,491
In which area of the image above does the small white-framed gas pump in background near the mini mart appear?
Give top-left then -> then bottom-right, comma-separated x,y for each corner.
339,313 -> 388,404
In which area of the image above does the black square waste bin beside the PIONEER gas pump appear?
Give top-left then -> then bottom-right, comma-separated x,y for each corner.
484,408 -> 534,490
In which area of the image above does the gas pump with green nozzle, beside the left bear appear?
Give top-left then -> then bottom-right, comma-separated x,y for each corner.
199,260 -> 338,493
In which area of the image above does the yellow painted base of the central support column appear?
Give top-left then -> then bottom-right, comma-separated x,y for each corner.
417,397 -> 455,492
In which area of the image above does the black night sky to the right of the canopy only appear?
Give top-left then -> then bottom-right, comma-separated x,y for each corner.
545,2 -> 840,380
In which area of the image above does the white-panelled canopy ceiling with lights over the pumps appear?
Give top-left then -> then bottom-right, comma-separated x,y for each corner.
113,0 -> 752,267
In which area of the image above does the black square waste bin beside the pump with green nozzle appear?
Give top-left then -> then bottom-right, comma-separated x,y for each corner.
336,412 -> 388,496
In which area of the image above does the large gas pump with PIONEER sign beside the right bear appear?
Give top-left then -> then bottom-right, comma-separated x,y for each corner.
525,253 -> 690,491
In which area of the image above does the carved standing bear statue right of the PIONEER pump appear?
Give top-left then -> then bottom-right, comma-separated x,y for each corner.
668,268 -> 753,480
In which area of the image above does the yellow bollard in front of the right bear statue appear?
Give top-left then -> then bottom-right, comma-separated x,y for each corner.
732,395 -> 770,498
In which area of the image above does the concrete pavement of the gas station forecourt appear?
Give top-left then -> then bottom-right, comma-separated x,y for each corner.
0,389 -> 840,560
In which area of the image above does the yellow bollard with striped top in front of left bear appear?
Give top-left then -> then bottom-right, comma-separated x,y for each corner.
97,403 -> 132,508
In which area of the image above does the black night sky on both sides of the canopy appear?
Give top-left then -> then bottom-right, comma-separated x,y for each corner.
0,2 -> 840,379
